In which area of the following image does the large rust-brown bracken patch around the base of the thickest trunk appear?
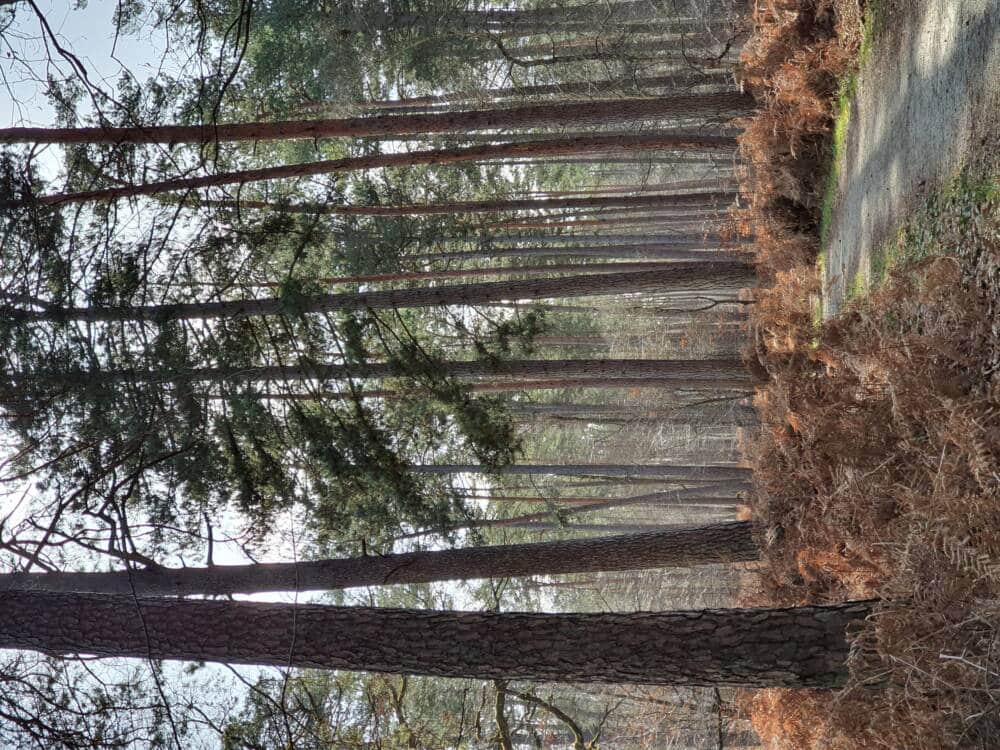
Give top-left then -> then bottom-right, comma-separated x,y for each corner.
748,256 -> 1000,748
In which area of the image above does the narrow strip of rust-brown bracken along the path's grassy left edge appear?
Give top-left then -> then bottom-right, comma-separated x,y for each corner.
737,0 -> 861,278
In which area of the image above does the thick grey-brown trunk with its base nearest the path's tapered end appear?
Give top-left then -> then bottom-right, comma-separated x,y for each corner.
0,261 -> 752,322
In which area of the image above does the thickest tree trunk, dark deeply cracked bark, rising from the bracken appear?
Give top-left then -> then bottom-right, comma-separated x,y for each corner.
0,591 -> 872,688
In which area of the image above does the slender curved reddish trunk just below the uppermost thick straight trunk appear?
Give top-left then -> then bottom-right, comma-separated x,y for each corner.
27,134 -> 736,206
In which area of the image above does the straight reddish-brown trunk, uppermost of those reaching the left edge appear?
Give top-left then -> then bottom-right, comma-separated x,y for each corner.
0,91 -> 753,144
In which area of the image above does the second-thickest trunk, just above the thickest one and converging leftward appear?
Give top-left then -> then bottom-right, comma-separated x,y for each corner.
0,521 -> 758,596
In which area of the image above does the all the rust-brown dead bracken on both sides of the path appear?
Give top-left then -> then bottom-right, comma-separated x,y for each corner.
739,0 -> 1000,750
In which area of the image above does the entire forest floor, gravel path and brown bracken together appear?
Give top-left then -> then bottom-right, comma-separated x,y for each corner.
737,0 -> 1000,750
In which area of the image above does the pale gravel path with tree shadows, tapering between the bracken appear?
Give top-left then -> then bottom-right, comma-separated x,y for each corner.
823,0 -> 1000,317
